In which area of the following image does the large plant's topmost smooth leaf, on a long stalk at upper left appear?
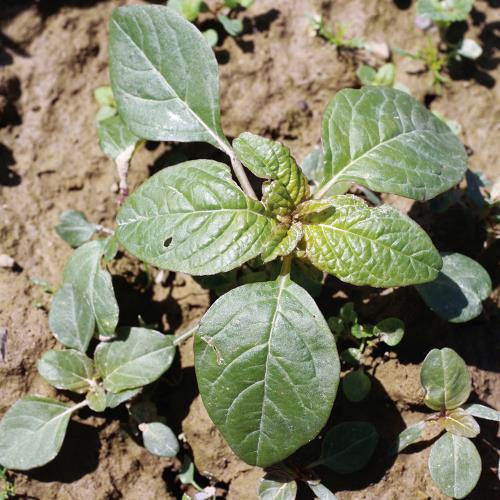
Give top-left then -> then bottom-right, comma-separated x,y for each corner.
109,5 -> 227,150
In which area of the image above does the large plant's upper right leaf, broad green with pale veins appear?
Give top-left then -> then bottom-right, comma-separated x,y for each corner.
321,87 -> 467,200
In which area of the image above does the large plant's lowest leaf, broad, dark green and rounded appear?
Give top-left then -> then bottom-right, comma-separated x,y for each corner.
195,277 -> 339,467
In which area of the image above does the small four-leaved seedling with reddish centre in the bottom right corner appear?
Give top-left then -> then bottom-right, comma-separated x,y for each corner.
393,348 -> 500,498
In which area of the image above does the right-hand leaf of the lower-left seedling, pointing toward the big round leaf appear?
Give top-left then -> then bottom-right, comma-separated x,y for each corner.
94,327 -> 175,393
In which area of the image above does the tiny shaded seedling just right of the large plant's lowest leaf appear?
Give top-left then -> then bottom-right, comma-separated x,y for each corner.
328,302 -> 404,403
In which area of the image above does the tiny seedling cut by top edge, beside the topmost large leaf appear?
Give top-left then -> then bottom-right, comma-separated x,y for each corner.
167,0 -> 255,47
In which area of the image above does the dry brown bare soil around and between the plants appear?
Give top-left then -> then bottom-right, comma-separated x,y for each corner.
0,0 -> 500,500
